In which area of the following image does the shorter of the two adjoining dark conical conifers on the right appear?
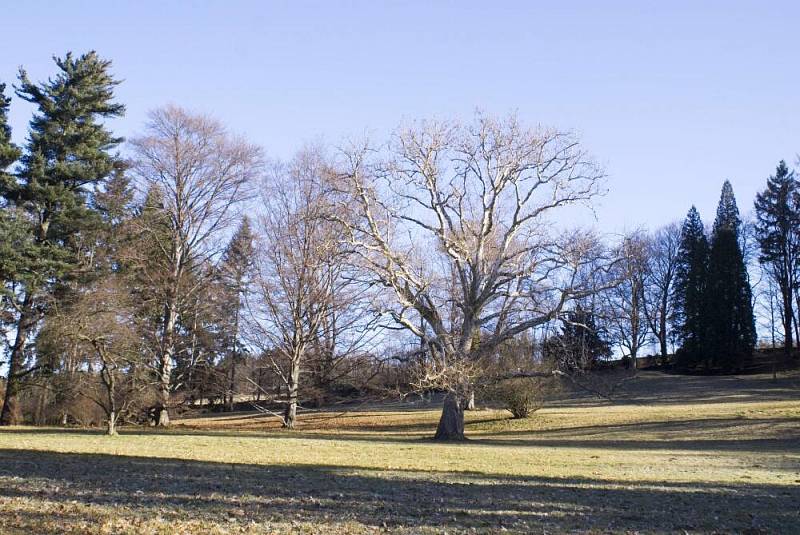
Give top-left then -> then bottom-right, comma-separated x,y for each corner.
673,206 -> 709,367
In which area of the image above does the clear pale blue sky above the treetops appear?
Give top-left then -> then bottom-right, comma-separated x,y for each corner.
0,0 -> 800,231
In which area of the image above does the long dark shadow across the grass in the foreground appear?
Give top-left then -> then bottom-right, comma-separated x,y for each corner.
0,449 -> 800,533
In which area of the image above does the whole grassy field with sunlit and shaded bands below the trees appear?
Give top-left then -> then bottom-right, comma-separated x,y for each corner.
0,373 -> 800,534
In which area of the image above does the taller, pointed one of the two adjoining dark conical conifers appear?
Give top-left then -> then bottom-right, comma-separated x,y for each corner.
706,180 -> 756,370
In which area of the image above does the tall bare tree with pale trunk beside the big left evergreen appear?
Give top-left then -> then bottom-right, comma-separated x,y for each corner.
132,106 -> 261,426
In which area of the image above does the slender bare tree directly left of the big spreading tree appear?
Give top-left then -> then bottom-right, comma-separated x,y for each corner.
250,150 -> 340,429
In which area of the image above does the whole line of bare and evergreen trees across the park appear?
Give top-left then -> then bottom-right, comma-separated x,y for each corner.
0,52 -> 800,439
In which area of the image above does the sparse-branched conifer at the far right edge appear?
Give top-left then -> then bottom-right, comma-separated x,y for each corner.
755,160 -> 800,357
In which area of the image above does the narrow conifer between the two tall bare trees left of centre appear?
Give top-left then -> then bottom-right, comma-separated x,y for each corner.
222,217 -> 255,411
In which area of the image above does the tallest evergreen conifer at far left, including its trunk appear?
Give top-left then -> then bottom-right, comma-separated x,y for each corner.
0,52 -> 124,425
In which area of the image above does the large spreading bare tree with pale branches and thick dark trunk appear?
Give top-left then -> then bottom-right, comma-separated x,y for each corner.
339,114 -> 602,440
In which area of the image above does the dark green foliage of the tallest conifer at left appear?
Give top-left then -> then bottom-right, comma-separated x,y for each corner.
0,52 -> 124,293
